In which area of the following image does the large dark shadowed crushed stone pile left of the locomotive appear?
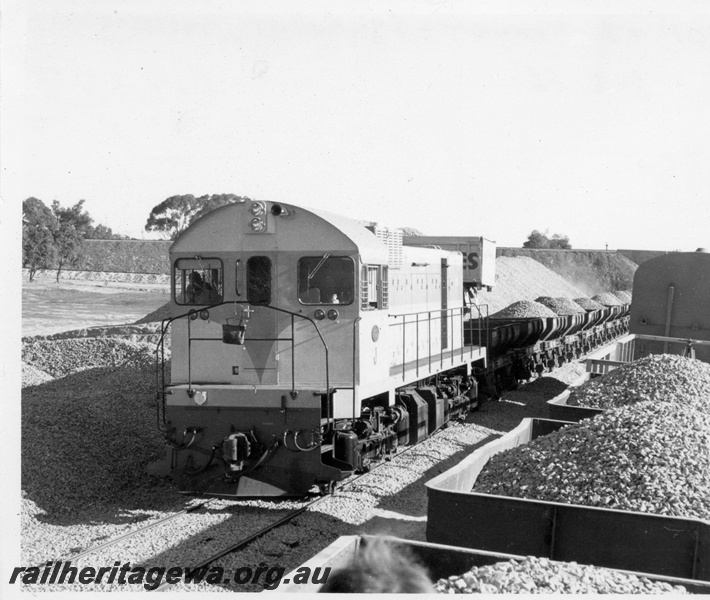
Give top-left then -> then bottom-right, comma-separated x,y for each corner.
21,364 -> 174,519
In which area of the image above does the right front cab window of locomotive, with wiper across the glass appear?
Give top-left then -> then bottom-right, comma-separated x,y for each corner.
298,254 -> 355,304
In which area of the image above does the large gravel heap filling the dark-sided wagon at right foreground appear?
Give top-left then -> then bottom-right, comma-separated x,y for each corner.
473,402 -> 710,519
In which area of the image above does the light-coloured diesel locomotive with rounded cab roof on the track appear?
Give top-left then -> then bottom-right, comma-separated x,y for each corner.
158,200 -> 486,497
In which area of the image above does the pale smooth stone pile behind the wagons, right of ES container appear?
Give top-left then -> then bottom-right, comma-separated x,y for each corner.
478,256 -> 586,314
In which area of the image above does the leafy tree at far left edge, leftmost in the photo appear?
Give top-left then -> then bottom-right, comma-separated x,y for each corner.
22,197 -> 59,281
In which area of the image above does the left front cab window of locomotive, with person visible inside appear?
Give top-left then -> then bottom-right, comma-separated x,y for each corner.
173,258 -> 224,305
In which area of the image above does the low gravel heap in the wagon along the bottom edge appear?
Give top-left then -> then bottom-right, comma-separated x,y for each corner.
436,556 -> 688,594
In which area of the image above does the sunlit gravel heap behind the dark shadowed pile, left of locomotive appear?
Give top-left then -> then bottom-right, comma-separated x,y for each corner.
22,337 -> 162,377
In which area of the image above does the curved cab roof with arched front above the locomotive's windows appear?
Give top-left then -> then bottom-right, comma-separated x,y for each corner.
170,201 -> 388,264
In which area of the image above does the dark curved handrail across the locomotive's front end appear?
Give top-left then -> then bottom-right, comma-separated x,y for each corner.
156,300 -> 333,428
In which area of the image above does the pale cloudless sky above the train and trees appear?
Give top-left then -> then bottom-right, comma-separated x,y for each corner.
0,0 -> 710,250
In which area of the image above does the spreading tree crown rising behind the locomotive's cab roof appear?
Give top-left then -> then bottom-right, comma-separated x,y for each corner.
145,194 -> 248,240
